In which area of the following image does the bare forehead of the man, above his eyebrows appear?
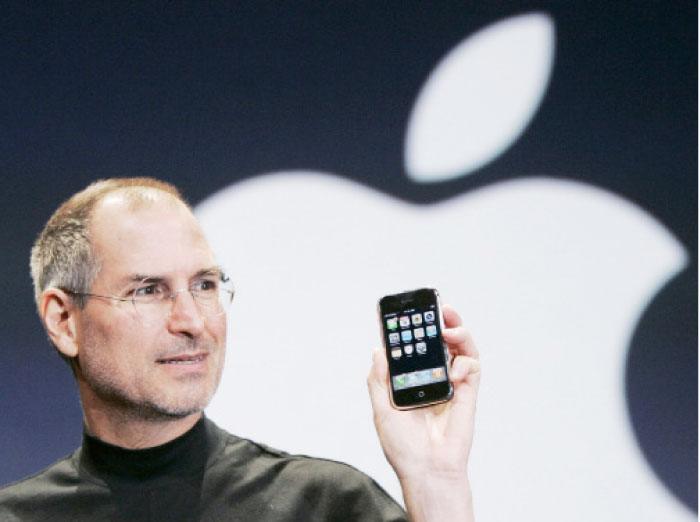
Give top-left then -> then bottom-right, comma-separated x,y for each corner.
90,190 -> 215,280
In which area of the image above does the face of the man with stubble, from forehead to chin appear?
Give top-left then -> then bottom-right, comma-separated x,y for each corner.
78,195 -> 226,418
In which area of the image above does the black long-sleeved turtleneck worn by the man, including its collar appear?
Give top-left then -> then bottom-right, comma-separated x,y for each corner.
0,418 -> 406,522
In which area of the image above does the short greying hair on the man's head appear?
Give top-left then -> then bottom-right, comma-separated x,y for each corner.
30,177 -> 190,308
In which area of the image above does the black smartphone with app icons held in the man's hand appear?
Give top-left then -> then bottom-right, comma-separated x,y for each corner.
379,288 -> 453,410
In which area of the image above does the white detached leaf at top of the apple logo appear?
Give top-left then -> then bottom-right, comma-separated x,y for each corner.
404,13 -> 554,183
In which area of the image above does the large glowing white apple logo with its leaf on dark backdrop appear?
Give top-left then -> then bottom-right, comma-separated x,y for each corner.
196,15 -> 695,522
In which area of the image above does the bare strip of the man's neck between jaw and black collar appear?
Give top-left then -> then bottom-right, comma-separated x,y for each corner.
83,407 -> 202,449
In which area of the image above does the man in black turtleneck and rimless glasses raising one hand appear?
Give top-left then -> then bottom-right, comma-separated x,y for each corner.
0,178 -> 480,521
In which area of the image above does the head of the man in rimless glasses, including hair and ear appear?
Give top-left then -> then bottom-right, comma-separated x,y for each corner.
31,178 -> 226,418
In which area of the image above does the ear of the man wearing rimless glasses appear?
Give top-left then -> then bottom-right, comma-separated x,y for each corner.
39,288 -> 80,358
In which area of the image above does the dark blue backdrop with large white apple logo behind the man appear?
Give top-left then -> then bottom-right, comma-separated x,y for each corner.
0,2 -> 697,520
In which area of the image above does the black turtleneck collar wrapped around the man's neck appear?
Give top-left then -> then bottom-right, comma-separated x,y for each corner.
78,416 -> 224,485
